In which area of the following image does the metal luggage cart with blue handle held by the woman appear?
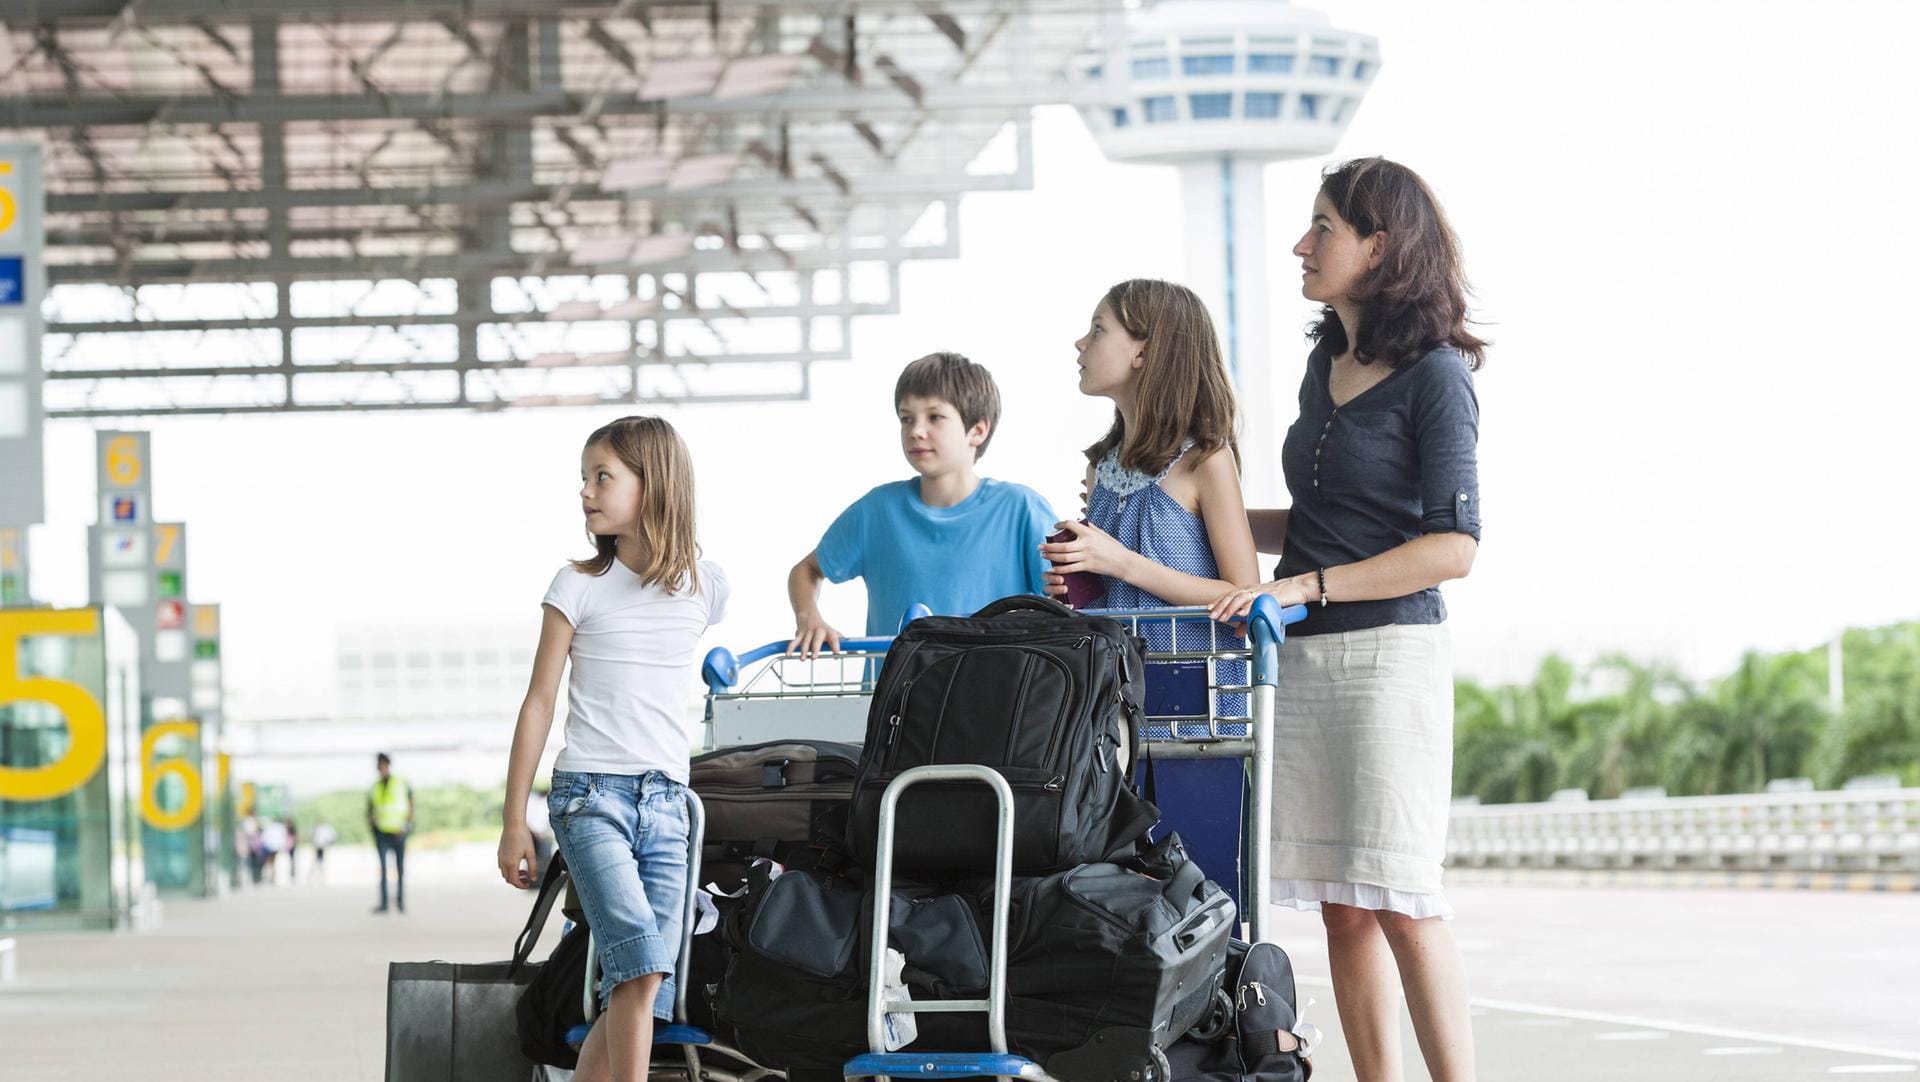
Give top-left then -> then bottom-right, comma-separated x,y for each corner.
843,595 -> 1308,1082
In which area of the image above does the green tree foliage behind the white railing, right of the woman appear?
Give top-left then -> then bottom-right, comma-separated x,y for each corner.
1453,623 -> 1920,804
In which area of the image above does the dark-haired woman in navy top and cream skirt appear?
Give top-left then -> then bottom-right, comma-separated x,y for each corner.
1213,157 -> 1486,1082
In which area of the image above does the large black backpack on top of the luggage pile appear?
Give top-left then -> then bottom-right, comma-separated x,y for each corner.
849,597 -> 1160,875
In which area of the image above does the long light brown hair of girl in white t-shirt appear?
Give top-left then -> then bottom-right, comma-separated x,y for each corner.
572,416 -> 701,593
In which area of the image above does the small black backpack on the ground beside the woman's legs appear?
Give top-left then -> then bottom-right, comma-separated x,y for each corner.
1167,942 -> 1317,1082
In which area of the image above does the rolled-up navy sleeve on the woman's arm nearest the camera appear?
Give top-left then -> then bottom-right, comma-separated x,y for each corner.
1411,349 -> 1480,541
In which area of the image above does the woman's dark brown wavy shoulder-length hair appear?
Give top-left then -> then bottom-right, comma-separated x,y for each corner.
1308,157 -> 1486,368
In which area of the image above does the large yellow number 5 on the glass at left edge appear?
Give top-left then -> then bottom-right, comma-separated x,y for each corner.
0,608 -> 108,800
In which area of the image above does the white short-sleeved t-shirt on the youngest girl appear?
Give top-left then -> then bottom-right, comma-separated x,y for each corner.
543,560 -> 730,783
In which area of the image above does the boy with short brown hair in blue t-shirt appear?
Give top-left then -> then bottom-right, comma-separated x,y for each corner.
787,353 -> 1054,656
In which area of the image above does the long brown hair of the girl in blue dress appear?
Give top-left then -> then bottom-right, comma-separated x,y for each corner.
1087,278 -> 1240,474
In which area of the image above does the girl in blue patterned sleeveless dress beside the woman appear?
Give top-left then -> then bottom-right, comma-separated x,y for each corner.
1041,278 -> 1260,732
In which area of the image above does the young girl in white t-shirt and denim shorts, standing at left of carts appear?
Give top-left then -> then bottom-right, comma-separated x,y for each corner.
499,416 -> 728,1082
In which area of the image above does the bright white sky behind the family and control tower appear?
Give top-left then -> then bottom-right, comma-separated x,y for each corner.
18,0 -> 1920,719
